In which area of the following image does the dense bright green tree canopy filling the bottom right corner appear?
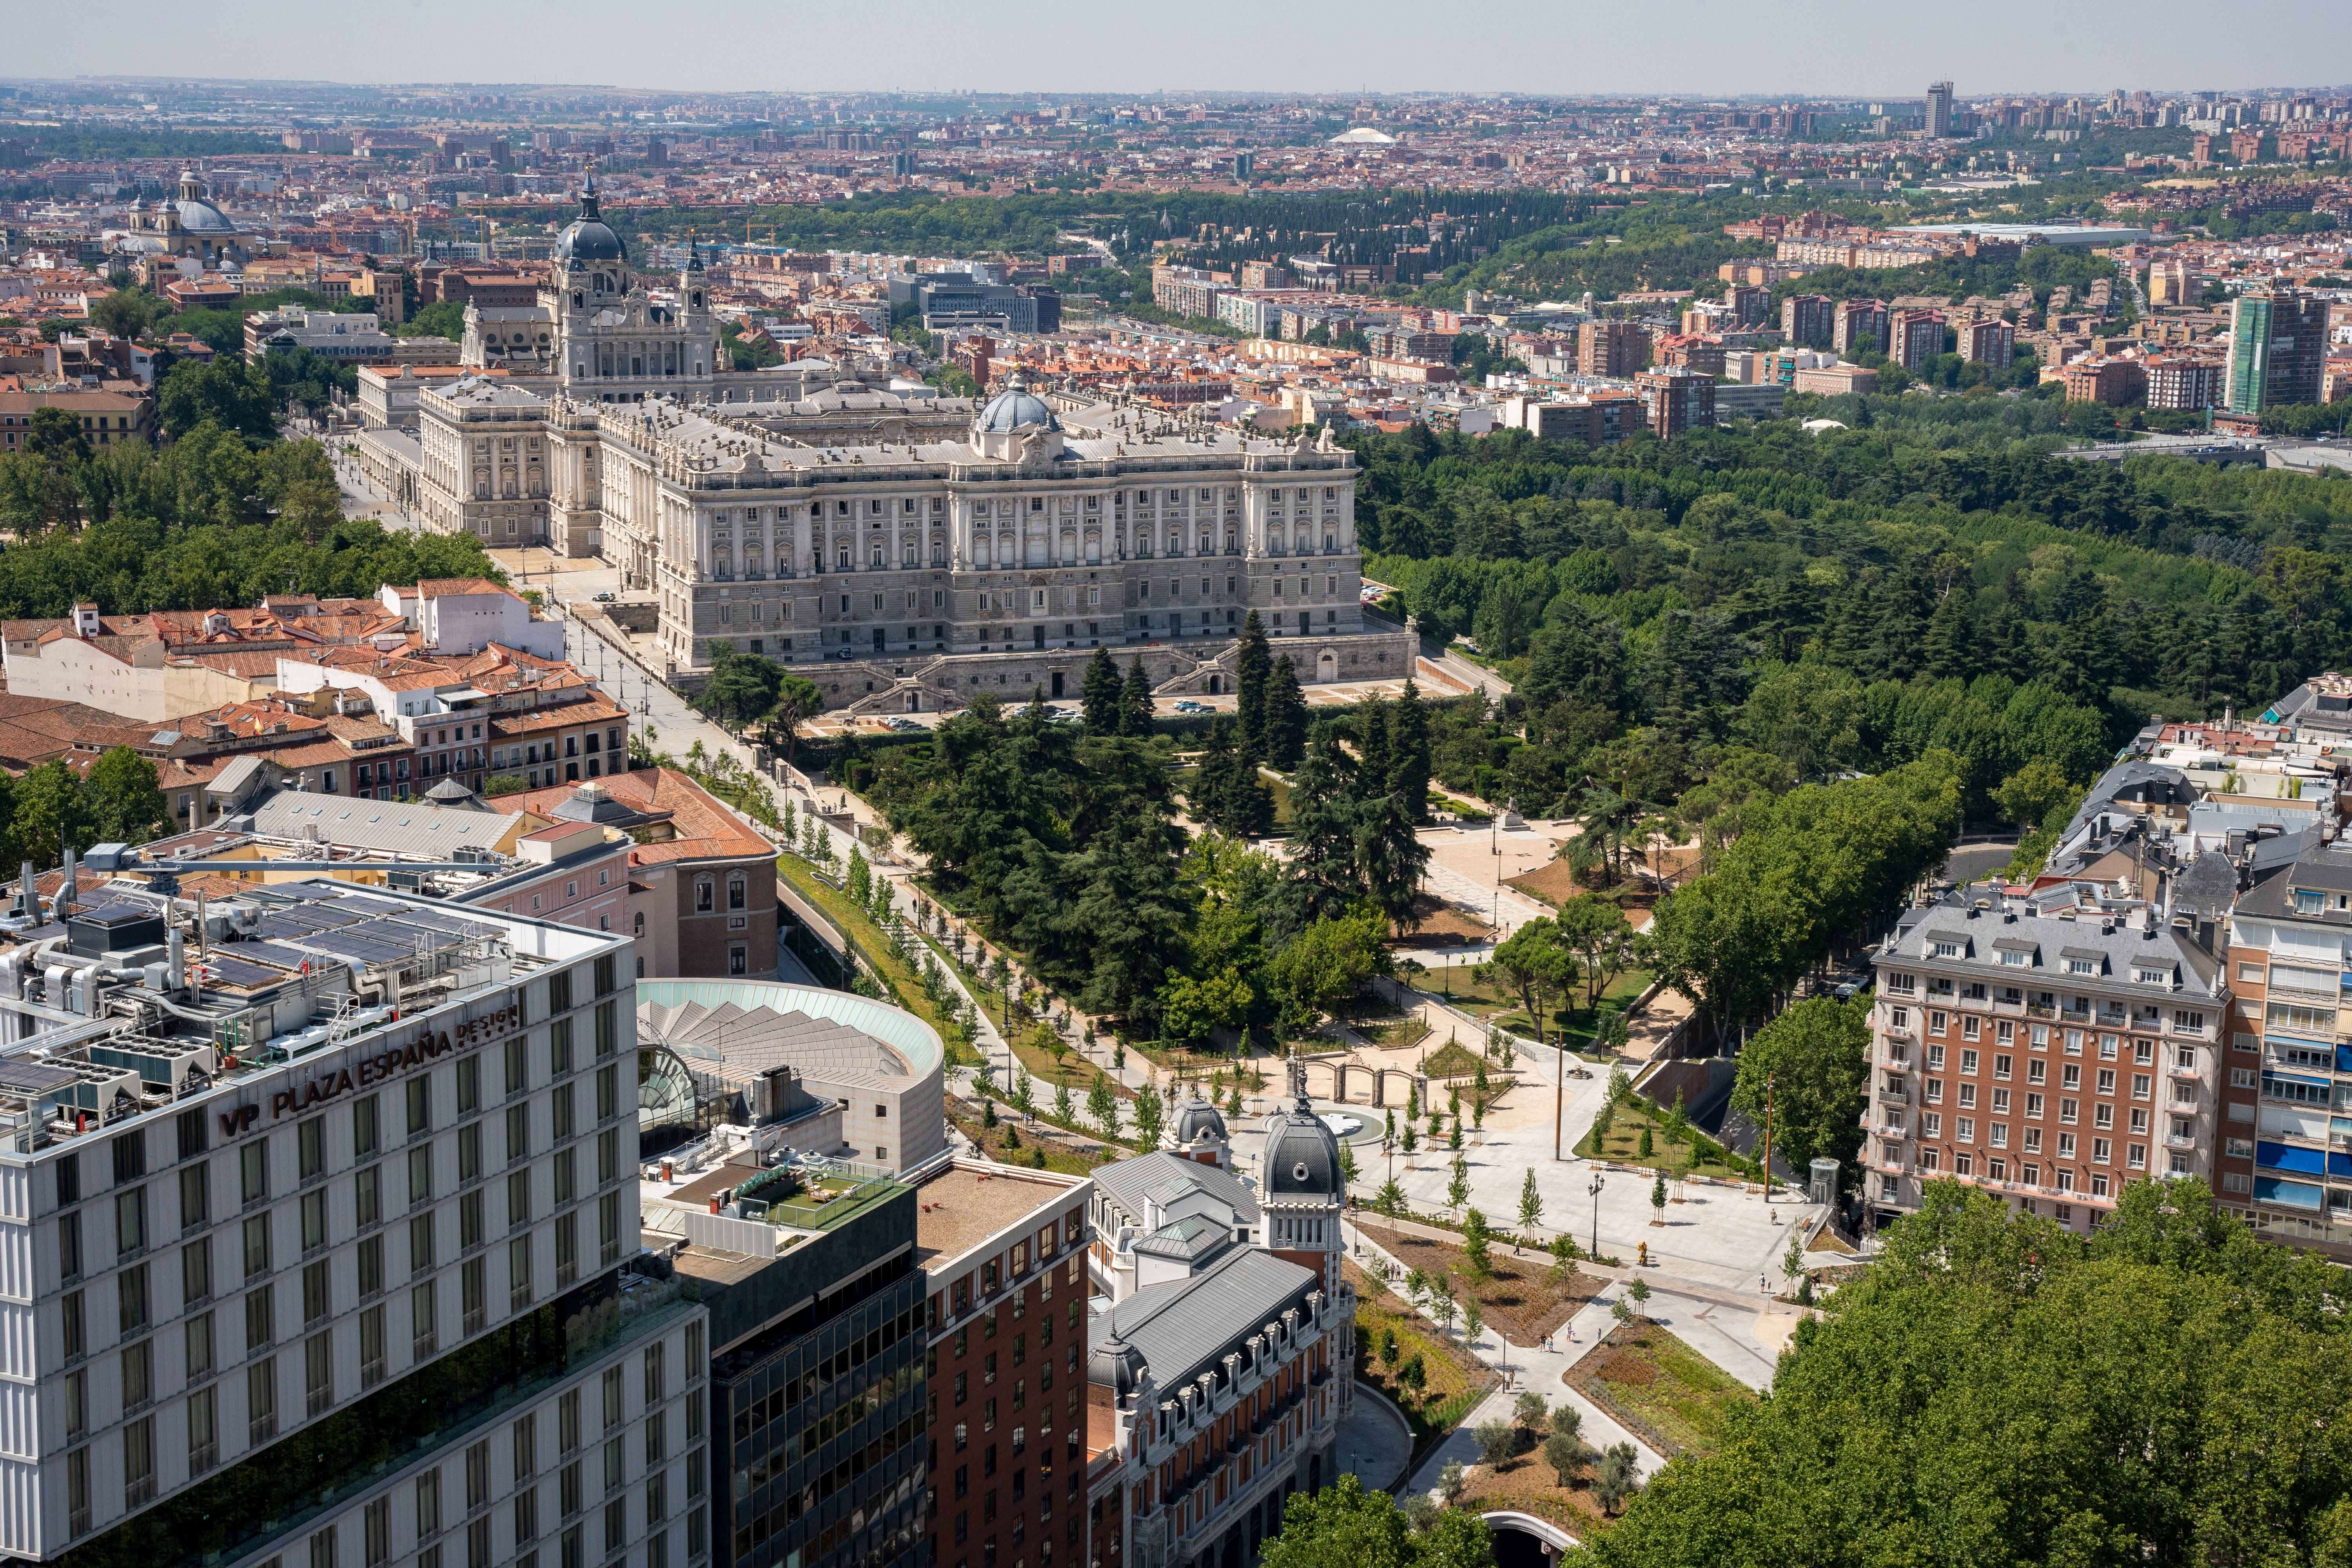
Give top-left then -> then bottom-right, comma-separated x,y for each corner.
1583,1180 -> 2352,1568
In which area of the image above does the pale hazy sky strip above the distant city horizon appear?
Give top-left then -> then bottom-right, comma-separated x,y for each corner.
18,0 -> 2352,96
